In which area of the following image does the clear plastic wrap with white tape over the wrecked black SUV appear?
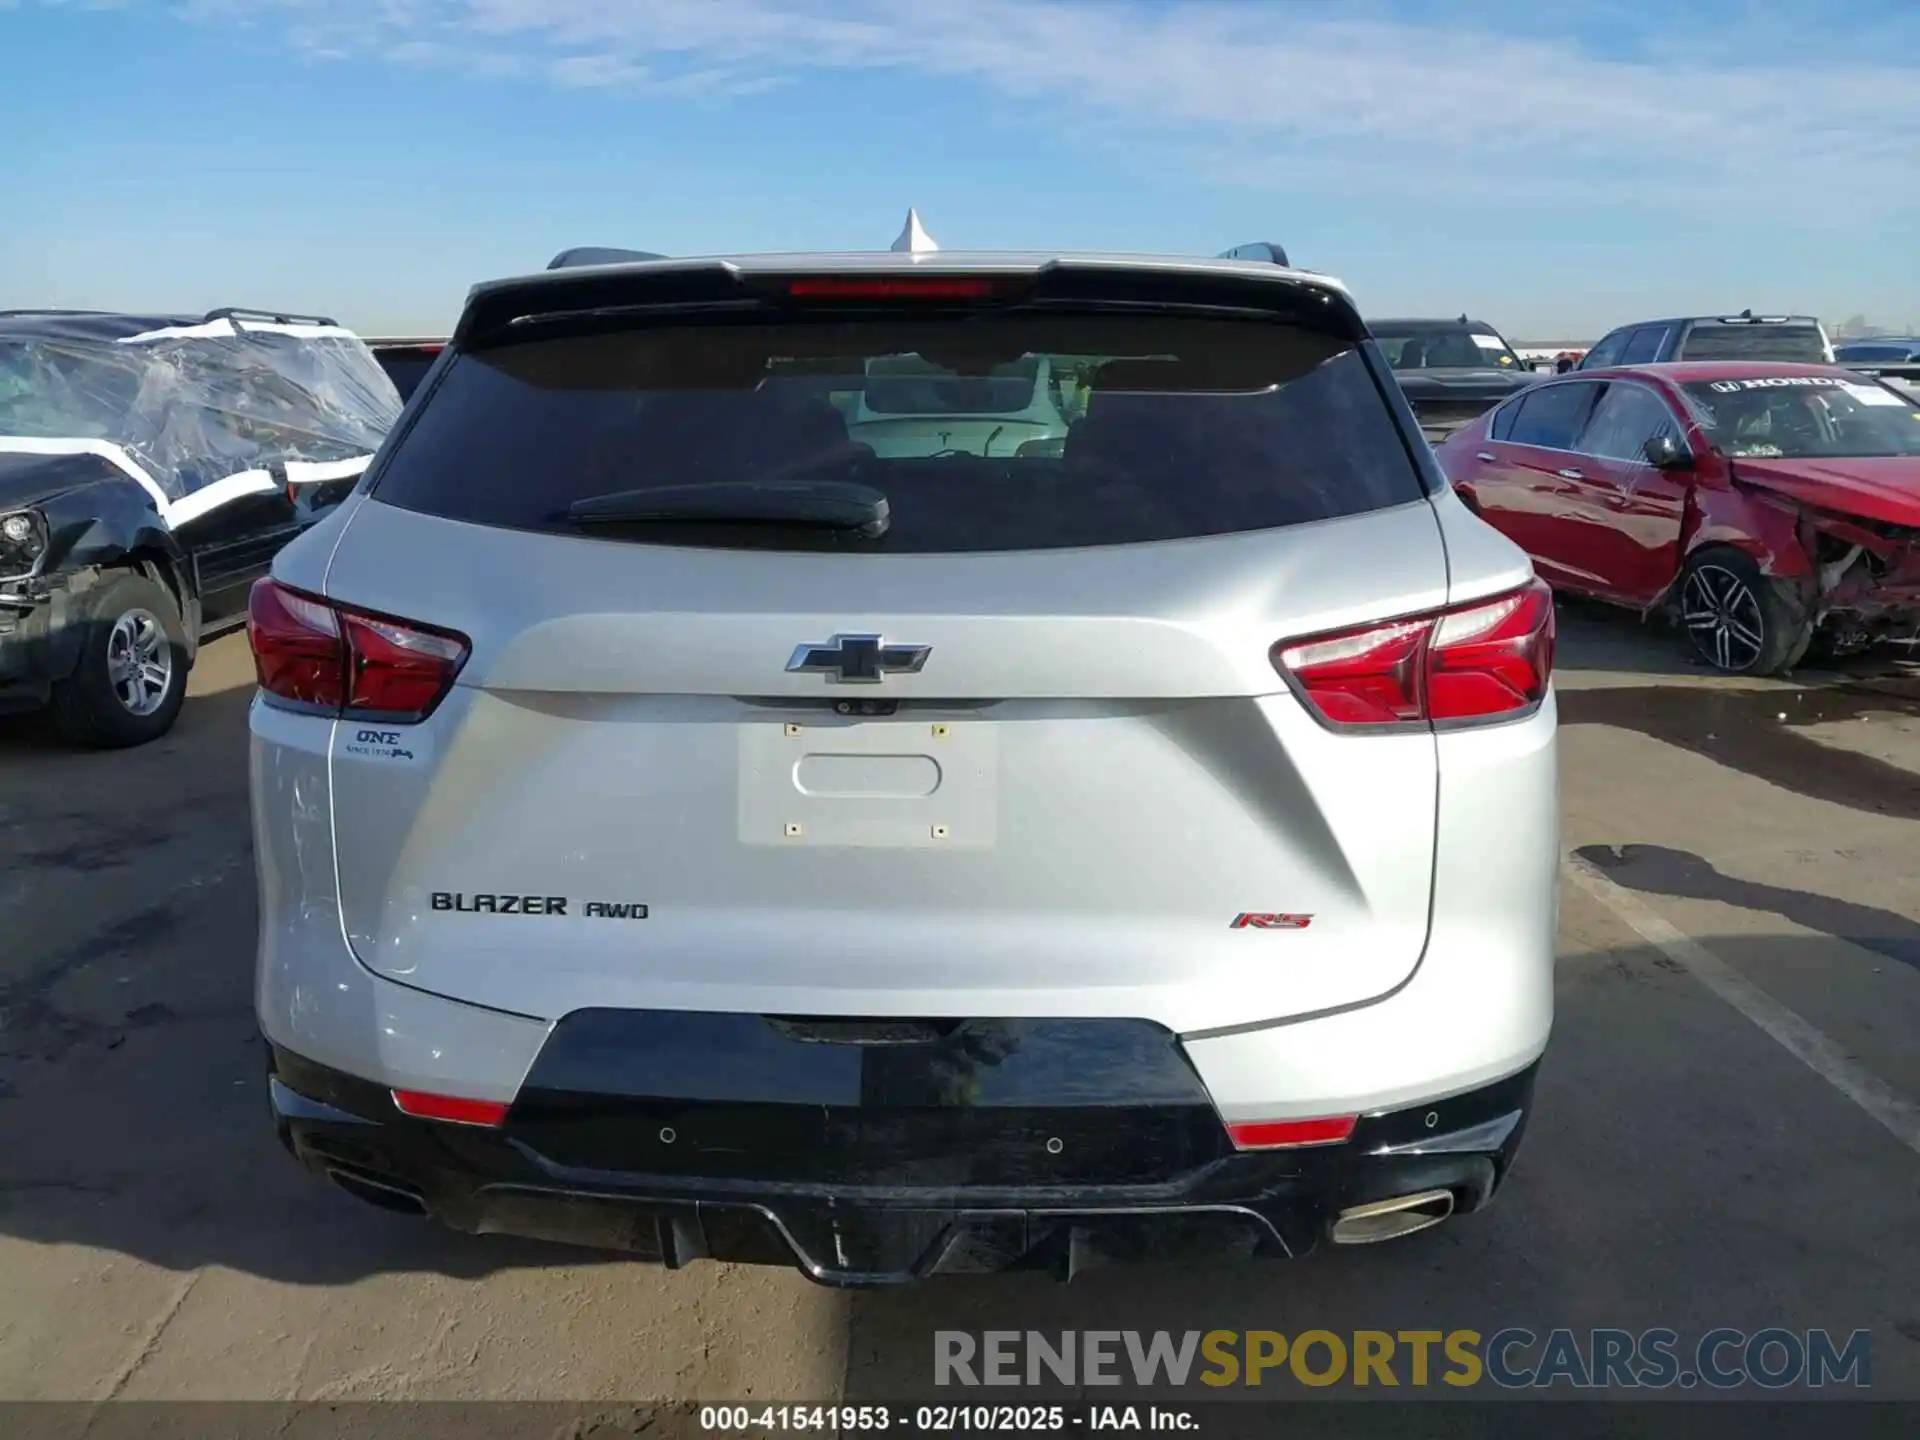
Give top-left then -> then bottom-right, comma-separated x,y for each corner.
0,313 -> 399,522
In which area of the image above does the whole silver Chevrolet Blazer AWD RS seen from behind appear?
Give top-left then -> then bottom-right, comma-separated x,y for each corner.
250,252 -> 1557,1284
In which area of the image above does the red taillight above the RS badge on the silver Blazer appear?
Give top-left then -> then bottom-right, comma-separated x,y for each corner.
1273,580 -> 1553,730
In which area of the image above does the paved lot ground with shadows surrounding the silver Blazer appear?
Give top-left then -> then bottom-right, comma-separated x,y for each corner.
0,607 -> 1920,1400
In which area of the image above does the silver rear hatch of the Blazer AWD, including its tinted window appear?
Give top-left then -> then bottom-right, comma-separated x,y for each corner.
314,257 -> 1448,1031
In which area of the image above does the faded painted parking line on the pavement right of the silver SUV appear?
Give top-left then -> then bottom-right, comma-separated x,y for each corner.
1567,854 -> 1920,1154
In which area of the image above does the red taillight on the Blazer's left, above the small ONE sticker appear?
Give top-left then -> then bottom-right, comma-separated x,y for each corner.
246,580 -> 470,724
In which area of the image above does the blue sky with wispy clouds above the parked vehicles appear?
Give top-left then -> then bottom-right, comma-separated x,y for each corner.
11,0 -> 1920,340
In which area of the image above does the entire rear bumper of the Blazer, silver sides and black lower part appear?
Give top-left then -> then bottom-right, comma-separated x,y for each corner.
252,672 -> 1559,1284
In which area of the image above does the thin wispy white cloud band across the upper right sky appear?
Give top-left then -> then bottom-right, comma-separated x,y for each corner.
112,0 -> 1920,211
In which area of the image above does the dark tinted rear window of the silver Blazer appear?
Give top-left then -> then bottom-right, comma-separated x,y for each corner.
374,311 -> 1425,553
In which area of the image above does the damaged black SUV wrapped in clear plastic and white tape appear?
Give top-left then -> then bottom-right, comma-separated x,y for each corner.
0,309 -> 399,749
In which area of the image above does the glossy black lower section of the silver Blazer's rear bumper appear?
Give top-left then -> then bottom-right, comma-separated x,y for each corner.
269,1036 -> 1536,1286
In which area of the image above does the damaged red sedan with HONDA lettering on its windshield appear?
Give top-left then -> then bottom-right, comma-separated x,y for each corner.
1436,361 -> 1920,674
